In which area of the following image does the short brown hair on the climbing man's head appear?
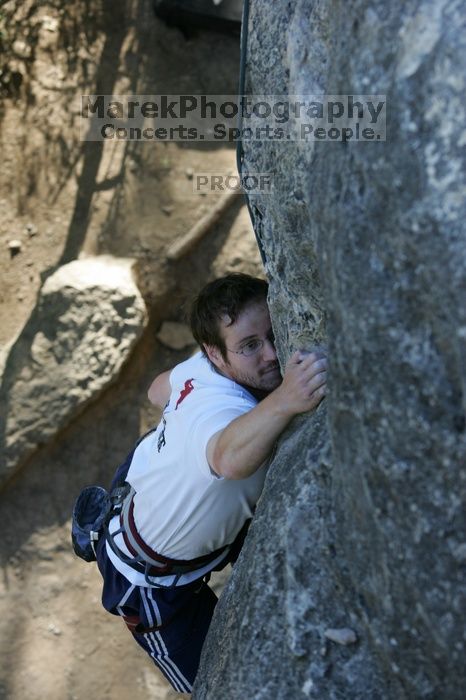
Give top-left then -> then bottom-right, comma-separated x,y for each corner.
189,272 -> 269,360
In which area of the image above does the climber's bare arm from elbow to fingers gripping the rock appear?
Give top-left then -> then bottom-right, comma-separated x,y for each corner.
207,351 -> 327,479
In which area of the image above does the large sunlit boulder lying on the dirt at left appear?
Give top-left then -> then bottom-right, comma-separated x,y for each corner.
0,256 -> 146,482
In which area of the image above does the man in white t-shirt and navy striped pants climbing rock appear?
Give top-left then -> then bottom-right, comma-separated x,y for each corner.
96,274 -> 327,692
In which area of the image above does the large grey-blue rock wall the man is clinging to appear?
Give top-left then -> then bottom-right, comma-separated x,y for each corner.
193,0 -> 466,700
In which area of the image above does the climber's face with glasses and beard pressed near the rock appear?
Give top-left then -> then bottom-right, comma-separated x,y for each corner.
206,301 -> 282,393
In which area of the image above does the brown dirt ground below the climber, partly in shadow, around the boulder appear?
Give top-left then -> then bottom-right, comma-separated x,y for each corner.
0,0 -> 261,700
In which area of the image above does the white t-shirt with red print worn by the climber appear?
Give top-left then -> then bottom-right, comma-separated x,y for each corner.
107,352 -> 266,585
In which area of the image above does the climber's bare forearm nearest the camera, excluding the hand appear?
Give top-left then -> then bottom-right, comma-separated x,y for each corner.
209,392 -> 292,479
